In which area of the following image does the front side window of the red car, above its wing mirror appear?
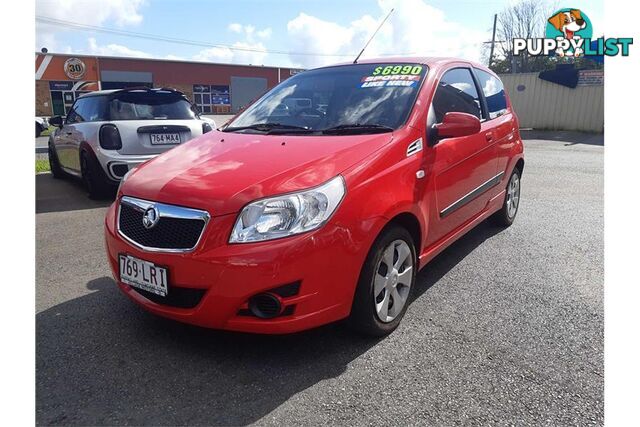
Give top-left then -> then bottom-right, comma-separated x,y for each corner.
433,68 -> 483,123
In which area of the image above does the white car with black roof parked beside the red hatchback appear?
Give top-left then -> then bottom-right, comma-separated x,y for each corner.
49,87 -> 215,197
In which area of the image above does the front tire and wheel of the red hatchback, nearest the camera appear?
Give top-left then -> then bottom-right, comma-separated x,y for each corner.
348,225 -> 418,337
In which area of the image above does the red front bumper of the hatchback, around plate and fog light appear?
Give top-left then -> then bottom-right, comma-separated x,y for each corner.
105,201 -> 366,334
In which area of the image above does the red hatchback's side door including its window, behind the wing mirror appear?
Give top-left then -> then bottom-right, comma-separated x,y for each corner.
427,67 -> 497,243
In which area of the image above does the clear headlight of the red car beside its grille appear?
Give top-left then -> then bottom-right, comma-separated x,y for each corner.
229,175 -> 345,243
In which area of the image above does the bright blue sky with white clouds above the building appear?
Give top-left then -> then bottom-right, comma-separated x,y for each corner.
35,0 -> 604,68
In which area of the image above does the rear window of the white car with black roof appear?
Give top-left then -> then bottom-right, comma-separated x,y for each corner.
109,90 -> 196,120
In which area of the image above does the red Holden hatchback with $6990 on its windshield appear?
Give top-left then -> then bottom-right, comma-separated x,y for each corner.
105,58 -> 524,335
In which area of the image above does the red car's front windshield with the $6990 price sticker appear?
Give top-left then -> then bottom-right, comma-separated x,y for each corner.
224,63 -> 427,133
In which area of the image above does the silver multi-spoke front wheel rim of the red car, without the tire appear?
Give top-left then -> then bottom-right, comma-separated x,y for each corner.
373,240 -> 414,323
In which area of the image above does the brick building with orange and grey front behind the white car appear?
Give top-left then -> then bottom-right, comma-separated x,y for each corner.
36,53 -> 299,116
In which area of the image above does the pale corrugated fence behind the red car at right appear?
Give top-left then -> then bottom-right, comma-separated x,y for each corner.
500,73 -> 604,132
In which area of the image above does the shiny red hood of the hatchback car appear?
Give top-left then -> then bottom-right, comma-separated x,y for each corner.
117,131 -> 393,216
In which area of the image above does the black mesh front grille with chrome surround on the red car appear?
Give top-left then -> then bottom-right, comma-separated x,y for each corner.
118,197 -> 208,251
